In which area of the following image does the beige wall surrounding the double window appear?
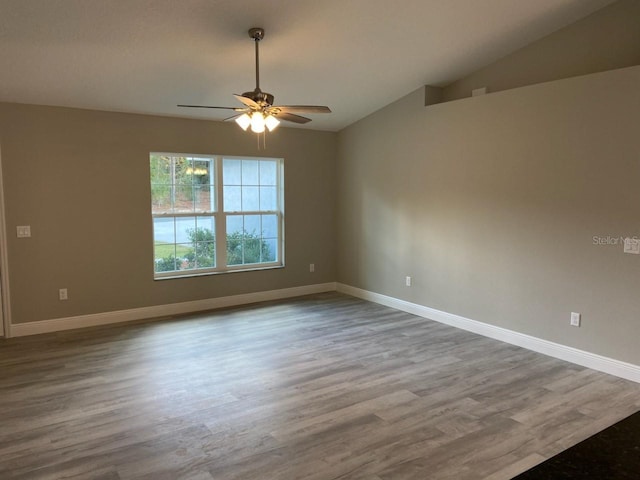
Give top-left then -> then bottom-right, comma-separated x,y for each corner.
0,104 -> 336,323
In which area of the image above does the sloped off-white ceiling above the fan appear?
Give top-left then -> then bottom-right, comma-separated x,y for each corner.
0,0 -> 612,131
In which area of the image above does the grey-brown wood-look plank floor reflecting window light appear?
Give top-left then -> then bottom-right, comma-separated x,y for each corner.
0,293 -> 640,480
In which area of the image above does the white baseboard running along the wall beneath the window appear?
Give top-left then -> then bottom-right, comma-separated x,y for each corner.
11,282 -> 336,337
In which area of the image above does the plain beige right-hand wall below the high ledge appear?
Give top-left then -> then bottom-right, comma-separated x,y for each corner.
338,66 -> 640,364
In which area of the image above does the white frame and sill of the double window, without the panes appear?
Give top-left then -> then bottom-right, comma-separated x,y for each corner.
149,152 -> 284,280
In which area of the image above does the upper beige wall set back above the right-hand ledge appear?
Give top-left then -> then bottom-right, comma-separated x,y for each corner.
441,0 -> 640,101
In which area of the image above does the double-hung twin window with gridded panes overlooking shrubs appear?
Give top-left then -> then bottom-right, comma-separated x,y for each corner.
150,153 -> 284,278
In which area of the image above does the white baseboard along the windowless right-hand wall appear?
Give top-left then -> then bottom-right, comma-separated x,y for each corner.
336,283 -> 640,383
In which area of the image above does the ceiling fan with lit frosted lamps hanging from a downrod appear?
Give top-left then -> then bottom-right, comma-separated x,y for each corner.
178,27 -> 331,133
